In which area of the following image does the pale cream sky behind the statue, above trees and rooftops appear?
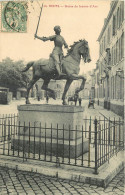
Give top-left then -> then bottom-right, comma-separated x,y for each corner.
0,0 -> 110,73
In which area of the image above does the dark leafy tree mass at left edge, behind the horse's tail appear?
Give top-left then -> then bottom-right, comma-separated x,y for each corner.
0,57 -> 31,92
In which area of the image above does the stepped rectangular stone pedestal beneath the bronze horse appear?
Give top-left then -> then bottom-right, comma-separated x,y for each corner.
12,104 -> 88,158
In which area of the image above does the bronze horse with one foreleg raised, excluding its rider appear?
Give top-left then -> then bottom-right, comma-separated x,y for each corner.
22,40 -> 91,105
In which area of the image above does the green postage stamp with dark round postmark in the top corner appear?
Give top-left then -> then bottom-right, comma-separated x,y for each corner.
1,1 -> 27,33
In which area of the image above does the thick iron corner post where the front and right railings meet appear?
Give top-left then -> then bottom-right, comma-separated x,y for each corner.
94,119 -> 98,174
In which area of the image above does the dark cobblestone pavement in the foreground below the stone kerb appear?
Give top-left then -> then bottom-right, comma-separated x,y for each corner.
0,167 -> 124,195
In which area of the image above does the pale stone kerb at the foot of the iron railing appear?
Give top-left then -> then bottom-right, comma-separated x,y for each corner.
0,151 -> 124,188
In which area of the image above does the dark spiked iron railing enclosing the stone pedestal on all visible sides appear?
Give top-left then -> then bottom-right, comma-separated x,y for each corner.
0,115 -> 124,174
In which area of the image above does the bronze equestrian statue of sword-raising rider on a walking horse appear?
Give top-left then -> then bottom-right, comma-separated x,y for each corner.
22,6 -> 91,105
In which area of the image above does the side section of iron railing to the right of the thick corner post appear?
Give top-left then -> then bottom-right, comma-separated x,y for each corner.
95,118 -> 124,171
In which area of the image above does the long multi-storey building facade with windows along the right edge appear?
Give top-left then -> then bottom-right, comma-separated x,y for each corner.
95,1 -> 124,116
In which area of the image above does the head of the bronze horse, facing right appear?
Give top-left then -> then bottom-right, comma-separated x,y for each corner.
78,40 -> 91,63
